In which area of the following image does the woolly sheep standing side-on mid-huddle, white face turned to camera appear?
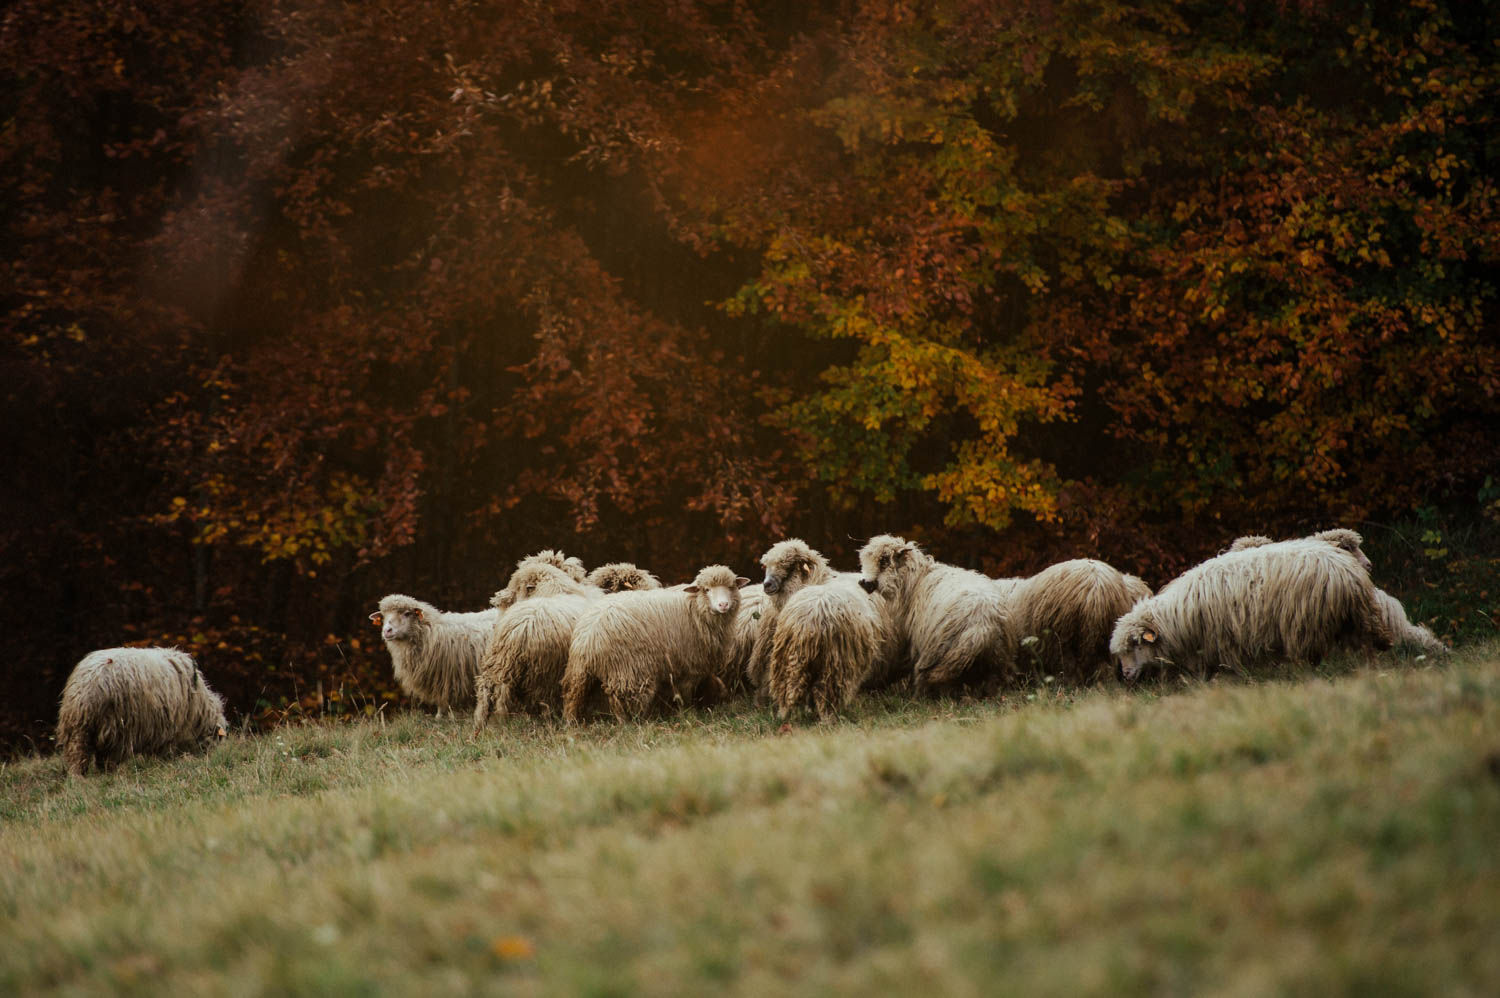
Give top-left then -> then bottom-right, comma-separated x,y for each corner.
563,564 -> 750,723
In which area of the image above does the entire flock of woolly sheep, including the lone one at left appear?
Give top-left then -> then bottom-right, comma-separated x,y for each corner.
57,530 -> 1446,774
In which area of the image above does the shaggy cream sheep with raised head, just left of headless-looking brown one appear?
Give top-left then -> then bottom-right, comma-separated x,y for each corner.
860,534 -> 1016,693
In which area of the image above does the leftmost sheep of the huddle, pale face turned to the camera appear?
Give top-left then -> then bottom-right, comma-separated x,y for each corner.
371,593 -> 501,717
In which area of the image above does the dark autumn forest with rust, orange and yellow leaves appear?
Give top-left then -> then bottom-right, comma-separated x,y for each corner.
0,0 -> 1500,750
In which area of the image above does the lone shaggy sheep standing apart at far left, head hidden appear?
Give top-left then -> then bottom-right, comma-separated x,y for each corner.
57,648 -> 228,776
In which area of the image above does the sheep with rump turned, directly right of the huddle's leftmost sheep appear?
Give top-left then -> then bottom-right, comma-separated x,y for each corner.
474,563 -> 605,735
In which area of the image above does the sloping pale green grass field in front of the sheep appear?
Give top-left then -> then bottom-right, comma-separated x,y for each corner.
0,644 -> 1500,995
